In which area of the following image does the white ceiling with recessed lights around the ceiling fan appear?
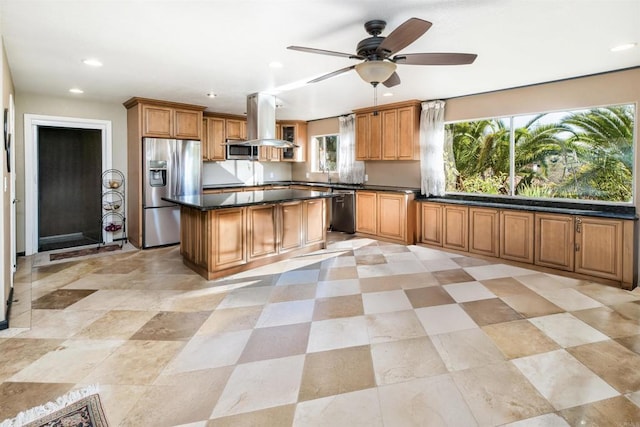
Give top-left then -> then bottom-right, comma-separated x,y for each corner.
0,0 -> 640,120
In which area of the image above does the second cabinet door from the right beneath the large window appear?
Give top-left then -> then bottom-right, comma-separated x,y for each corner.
534,213 -> 574,271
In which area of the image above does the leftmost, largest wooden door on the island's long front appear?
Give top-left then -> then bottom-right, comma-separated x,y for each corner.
210,208 -> 247,269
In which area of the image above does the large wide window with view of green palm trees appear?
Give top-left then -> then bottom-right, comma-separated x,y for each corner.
445,104 -> 635,203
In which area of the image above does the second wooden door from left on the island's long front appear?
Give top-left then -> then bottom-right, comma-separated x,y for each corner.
247,205 -> 278,261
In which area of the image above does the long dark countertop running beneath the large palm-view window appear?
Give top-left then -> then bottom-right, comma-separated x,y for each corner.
417,195 -> 638,219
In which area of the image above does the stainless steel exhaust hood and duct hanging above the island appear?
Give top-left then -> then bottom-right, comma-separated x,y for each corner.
227,93 -> 297,148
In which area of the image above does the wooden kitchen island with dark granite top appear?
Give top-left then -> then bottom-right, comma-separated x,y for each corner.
163,189 -> 334,280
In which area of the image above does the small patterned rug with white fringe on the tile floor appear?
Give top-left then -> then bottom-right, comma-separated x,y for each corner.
0,387 -> 108,427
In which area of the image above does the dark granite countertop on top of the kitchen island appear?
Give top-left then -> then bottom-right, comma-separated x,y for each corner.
162,190 -> 335,211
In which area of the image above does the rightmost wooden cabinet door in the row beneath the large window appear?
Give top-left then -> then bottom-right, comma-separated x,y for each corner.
575,217 -> 624,280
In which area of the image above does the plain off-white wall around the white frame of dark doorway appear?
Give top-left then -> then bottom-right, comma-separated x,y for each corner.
15,92 -> 127,252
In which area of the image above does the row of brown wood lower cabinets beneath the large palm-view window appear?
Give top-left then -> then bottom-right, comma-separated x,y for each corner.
417,202 -> 637,289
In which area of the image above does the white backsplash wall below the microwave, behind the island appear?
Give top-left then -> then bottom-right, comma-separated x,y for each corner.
202,160 -> 291,186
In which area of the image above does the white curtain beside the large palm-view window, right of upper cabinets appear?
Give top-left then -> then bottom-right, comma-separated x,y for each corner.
420,101 -> 446,196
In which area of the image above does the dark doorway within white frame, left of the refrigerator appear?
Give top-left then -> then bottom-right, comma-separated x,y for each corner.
38,126 -> 102,252
